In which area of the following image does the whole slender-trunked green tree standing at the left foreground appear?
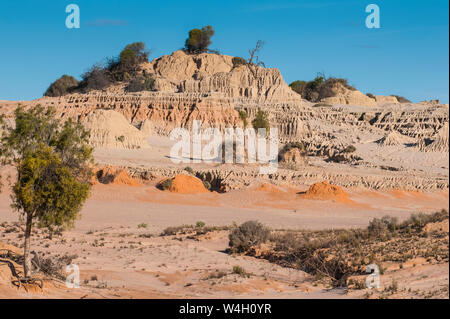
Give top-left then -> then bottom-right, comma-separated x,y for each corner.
0,105 -> 93,282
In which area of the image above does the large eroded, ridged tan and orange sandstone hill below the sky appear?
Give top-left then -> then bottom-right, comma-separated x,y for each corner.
0,51 -> 449,195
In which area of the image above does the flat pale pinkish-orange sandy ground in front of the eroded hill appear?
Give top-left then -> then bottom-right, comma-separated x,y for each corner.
0,137 -> 449,298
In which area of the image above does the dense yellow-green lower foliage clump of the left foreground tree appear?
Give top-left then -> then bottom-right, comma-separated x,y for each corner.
13,144 -> 90,228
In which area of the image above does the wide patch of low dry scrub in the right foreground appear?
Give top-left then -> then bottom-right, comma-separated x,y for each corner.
230,210 -> 449,286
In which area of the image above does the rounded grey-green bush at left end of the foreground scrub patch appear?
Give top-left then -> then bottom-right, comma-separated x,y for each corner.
229,221 -> 270,253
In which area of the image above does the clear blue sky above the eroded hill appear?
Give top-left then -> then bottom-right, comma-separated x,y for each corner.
0,0 -> 449,103
